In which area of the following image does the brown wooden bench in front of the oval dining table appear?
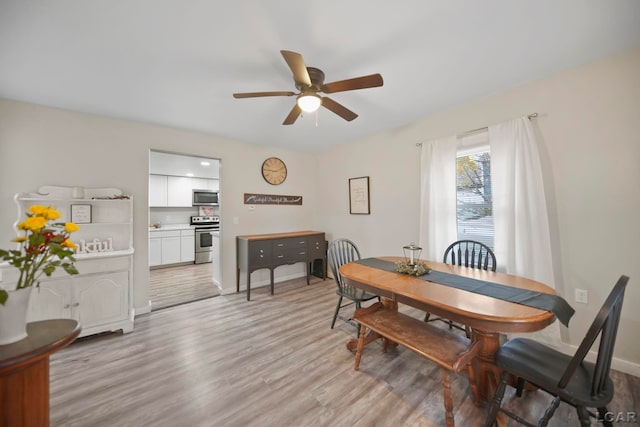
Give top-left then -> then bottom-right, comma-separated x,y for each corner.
353,302 -> 480,427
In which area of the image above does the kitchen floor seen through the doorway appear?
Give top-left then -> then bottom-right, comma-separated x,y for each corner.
149,263 -> 220,310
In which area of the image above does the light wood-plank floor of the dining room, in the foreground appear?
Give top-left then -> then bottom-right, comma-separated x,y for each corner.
50,278 -> 640,427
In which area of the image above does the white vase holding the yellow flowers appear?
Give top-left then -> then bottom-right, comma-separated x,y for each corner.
0,287 -> 32,345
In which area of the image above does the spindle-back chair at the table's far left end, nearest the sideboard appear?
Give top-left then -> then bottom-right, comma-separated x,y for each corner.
327,239 -> 380,334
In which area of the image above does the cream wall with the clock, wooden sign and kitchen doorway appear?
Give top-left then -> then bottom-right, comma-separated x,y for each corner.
0,99 -> 317,313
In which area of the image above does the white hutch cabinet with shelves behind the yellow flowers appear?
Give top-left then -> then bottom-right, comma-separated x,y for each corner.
11,187 -> 134,336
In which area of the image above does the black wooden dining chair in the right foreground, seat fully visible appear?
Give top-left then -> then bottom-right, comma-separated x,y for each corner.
484,276 -> 629,427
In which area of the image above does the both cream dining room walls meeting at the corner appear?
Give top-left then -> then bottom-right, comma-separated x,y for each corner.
0,48 -> 640,375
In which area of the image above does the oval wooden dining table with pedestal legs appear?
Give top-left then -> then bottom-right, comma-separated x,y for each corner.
339,256 -> 573,402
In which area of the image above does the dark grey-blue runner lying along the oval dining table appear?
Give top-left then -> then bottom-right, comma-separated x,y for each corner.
355,258 -> 575,327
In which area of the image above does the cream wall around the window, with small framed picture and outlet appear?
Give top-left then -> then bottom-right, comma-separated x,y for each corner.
318,47 -> 640,376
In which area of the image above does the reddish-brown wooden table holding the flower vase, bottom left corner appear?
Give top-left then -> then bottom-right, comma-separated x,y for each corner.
0,319 -> 81,427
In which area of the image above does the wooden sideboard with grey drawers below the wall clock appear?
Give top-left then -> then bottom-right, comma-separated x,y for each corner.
236,231 -> 327,301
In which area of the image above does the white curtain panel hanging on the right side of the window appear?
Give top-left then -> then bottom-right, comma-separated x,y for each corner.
489,117 -> 560,345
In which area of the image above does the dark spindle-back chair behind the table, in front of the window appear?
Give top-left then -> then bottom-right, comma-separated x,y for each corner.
424,240 -> 497,338
